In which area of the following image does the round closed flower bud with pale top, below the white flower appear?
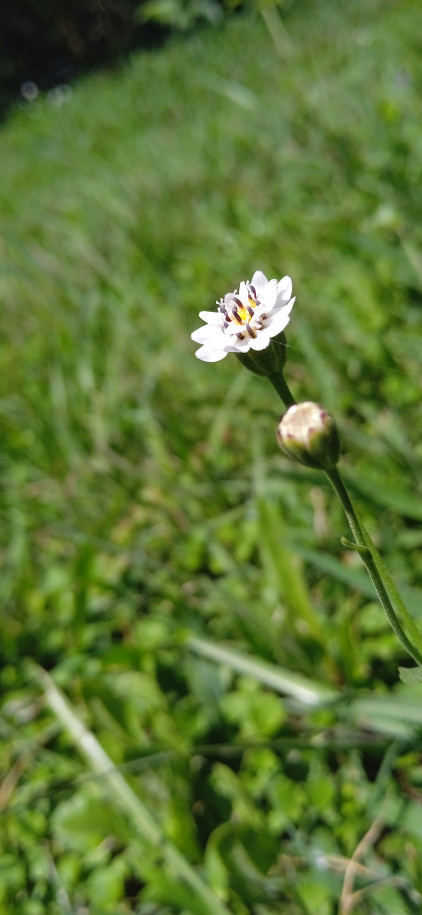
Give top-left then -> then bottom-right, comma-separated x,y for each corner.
277,401 -> 340,470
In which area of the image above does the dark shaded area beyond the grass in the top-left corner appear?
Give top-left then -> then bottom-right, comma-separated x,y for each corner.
0,0 -> 168,114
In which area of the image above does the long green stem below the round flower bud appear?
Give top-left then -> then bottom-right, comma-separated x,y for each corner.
325,467 -> 422,664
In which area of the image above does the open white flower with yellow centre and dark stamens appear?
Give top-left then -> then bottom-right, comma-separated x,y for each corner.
191,270 -> 295,362
